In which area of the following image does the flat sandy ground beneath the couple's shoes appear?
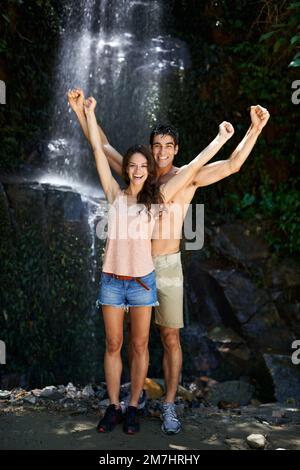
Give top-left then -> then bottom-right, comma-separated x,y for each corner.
0,408 -> 300,450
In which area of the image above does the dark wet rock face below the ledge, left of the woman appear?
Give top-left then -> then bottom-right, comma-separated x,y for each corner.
0,182 -> 103,388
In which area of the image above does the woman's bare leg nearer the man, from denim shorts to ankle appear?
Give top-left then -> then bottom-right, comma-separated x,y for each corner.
129,307 -> 152,406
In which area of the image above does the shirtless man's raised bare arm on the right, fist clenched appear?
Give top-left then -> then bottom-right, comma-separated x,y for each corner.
195,105 -> 270,187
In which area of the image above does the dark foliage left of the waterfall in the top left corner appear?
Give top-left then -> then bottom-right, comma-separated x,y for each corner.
0,0 -> 58,172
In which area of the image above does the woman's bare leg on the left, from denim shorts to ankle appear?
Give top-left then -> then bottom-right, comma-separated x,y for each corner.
102,305 -> 124,406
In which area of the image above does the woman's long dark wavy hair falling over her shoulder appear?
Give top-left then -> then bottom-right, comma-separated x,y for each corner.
122,145 -> 163,211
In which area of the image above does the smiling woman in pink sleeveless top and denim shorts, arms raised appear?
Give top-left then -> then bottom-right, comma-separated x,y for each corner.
84,98 -> 234,434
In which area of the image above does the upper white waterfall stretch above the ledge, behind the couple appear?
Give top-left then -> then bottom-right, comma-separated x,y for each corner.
47,0 -> 187,187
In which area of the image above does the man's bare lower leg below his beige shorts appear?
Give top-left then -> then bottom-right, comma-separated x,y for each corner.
160,326 -> 182,403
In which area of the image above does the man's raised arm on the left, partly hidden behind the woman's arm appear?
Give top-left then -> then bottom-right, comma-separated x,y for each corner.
68,88 -> 123,176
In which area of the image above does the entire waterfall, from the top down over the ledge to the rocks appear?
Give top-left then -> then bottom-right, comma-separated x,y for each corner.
6,0 -> 188,383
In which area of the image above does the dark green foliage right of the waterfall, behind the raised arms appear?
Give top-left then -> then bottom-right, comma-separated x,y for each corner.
163,0 -> 300,256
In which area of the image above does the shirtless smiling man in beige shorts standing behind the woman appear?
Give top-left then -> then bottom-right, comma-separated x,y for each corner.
68,89 -> 270,434
